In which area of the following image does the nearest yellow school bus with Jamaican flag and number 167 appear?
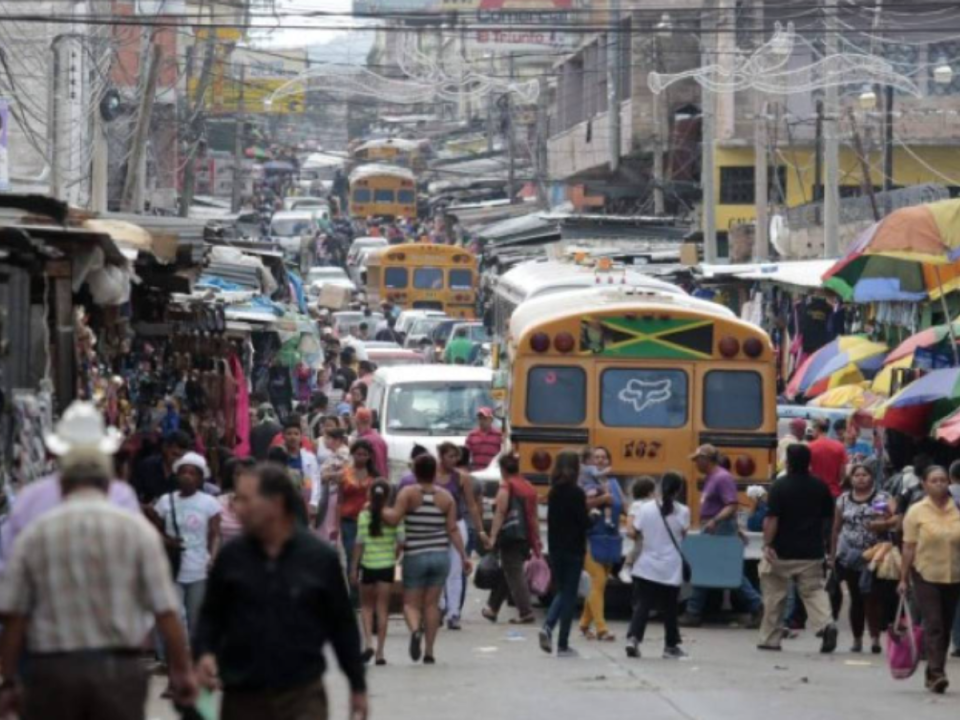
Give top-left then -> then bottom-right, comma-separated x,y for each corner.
502,288 -> 777,519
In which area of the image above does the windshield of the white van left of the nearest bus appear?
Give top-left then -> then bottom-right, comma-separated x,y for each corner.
385,381 -> 494,435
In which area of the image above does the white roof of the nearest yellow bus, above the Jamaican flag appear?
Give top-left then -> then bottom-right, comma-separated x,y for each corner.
510,287 -> 740,339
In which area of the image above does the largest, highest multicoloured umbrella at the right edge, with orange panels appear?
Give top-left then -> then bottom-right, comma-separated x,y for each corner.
823,200 -> 960,302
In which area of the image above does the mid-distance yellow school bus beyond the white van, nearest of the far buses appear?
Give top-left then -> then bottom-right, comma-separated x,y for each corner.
367,243 -> 478,319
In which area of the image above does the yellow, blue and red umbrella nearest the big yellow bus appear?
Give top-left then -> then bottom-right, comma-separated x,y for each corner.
786,335 -> 888,398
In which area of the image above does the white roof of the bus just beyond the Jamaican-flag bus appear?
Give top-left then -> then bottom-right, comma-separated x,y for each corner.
496,260 -> 686,305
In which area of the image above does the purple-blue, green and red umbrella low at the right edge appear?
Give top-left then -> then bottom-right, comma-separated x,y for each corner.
875,367 -> 960,436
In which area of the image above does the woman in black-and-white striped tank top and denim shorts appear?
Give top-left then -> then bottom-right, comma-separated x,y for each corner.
383,455 -> 471,665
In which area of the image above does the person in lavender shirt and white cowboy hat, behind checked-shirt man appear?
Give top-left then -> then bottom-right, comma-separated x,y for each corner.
0,400 -> 140,569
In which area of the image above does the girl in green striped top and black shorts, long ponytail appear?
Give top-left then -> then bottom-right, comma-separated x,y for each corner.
350,478 -> 403,665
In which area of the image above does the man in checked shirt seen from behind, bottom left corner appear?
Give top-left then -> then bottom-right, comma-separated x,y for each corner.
0,444 -> 197,720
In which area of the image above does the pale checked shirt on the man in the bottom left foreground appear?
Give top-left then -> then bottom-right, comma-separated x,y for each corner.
0,490 -> 179,653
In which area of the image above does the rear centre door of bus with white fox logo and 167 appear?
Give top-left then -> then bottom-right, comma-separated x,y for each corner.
593,360 -> 697,498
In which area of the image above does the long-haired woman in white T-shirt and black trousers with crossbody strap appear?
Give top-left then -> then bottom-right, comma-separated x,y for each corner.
627,472 -> 690,660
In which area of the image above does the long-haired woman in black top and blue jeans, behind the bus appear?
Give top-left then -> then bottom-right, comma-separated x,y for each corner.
540,450 -> 590,657
